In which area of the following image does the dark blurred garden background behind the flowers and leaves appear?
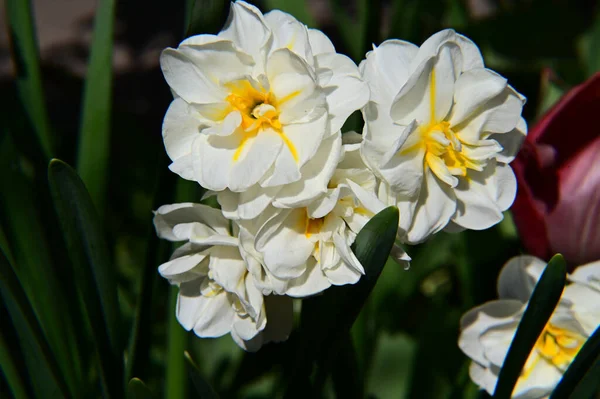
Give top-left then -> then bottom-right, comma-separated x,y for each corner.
0,0 -> 600,398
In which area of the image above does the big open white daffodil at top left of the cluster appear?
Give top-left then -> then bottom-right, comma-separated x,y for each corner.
161,1 -> 369,219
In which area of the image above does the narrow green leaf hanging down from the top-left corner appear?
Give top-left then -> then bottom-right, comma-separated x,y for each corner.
5,0 -> 53,159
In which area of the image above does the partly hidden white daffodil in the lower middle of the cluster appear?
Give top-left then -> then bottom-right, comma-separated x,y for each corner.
233,138 -> 410,297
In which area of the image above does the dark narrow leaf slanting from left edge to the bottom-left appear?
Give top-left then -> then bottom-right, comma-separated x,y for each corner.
0,252 -> 69,397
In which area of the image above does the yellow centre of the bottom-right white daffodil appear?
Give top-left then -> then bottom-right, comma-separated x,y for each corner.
518,323 -> 586,383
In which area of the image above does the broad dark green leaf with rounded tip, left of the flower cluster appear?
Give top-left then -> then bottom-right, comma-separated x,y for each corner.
48,159 -> 123,396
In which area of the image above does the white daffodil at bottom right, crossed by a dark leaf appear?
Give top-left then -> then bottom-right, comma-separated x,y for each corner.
458,256 -> 600,399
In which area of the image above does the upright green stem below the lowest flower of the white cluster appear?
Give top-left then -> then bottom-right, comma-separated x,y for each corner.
165,286 -> 187,399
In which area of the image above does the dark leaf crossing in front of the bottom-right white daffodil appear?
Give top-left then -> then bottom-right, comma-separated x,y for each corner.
494,255 -> 567,399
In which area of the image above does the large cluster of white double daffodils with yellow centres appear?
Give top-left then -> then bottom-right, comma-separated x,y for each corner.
155,1 -> 526,350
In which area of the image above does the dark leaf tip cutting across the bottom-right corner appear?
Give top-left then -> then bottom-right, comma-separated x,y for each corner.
550,327 -> 600,399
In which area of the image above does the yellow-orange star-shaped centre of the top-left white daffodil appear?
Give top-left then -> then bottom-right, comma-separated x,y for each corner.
225,80 -> 300,162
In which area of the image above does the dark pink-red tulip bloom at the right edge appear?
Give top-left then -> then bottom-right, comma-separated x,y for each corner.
511,73 -> 600,265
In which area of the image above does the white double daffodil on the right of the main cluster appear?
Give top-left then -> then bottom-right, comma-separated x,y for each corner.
360,30 -> 527,243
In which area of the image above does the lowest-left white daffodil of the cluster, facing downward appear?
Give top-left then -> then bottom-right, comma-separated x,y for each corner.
154,203 -> 293,351
